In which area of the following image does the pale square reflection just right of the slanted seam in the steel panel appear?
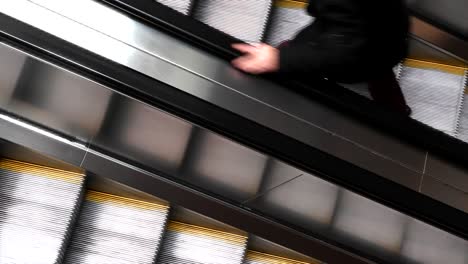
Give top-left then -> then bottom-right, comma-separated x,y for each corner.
246,174 -> 339,227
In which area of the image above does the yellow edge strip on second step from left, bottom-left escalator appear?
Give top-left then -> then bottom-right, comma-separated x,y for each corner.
86,191 -> 169,211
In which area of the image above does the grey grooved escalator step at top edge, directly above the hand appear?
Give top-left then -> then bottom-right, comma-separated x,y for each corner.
194,0 -> 272,42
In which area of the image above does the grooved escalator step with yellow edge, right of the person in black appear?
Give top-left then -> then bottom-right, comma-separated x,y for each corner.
399,60 -> 464,136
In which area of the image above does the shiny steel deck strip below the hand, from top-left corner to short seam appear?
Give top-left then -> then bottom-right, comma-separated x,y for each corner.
0,0 -> 436,188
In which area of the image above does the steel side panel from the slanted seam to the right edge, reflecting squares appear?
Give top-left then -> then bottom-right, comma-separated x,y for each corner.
247,172 -> 468,263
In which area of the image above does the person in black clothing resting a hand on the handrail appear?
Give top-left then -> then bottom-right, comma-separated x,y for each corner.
232,0 -> 410,114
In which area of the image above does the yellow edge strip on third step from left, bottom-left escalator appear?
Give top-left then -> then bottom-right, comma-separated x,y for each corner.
168,221 -> 247,245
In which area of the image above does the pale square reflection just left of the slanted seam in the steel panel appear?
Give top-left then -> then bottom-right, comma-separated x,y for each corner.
181,131 -> 267,201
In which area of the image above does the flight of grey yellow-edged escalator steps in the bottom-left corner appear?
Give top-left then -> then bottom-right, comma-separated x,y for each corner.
0,159 -> 319,264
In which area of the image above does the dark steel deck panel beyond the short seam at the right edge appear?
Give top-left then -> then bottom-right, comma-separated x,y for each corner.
425,153 -> 468,192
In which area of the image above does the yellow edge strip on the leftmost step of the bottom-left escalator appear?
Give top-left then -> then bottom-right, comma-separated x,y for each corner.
0,159 -> 85,184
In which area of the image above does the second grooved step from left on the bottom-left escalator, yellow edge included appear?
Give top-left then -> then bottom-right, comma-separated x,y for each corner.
65,191 -> 169,264
